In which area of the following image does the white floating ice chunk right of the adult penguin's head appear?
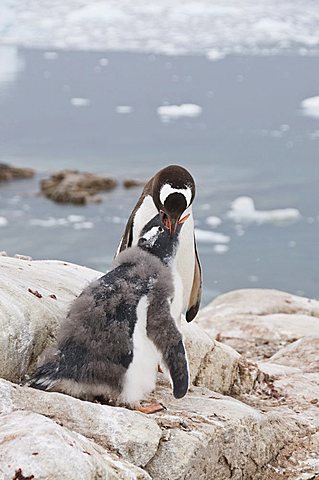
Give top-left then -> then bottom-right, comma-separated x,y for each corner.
227,197 -> 300,223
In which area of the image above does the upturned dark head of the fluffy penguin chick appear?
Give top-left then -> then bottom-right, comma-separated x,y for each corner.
138,214 -> 182,264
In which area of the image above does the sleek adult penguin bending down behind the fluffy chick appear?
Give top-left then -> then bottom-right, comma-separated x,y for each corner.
118,165 -> 202,322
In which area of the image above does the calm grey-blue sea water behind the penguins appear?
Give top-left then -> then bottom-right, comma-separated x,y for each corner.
0,49 -> 319,303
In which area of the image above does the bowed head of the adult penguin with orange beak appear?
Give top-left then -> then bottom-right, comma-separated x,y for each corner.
152,165 -> 195,237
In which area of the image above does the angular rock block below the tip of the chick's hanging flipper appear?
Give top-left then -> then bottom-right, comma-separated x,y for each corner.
146,387 -> 298,480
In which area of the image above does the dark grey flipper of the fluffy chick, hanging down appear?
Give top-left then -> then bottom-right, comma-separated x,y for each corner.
147,299 -> 189,398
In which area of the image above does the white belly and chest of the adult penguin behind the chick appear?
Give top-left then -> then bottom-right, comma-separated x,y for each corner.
132,195 -> 195,318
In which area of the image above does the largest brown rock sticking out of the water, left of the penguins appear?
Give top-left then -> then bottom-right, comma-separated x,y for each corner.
41,170 -> 117,204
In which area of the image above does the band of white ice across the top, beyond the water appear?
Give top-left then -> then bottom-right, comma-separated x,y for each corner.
0,0 -> 319,55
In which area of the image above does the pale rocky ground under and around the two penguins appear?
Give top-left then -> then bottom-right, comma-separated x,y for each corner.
0,255 -> 319,480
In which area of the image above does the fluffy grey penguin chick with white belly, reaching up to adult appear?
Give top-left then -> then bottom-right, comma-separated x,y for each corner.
28,214 -> 189,413
